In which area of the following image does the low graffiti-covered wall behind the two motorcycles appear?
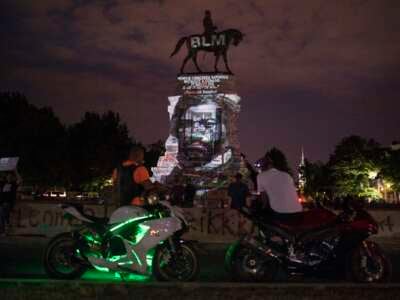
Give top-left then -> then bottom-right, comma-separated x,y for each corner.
7,203 -> 399,240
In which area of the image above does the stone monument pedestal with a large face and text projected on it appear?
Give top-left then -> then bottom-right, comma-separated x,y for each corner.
152,74 -> 247,197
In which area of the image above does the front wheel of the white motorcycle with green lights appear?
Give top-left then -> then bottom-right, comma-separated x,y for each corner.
153,243 -> 199,281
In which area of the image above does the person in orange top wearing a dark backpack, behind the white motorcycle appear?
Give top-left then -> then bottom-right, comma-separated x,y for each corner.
112,146 -> 156,206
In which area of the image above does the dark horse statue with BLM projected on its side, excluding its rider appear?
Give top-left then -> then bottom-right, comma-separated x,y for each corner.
170,29 -> 244,74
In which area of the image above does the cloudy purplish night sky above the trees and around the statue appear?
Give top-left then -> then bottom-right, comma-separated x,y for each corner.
0,0 -> 400,168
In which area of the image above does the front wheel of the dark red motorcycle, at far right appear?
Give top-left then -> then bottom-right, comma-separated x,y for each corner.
346,241 -> 392,283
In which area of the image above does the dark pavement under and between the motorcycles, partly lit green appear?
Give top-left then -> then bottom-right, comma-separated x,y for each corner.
0,237 -> 400,283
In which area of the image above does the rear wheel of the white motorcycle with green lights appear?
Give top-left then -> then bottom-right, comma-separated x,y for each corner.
44,233 -> 87,279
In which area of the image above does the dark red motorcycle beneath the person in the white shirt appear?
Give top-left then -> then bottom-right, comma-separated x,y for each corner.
225,200 -> 392,282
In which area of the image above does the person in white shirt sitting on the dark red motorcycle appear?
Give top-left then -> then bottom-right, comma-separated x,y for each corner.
257,157 -> 303,214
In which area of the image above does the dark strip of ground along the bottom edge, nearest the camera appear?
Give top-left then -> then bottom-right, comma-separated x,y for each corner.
0,280 -> 400,300
